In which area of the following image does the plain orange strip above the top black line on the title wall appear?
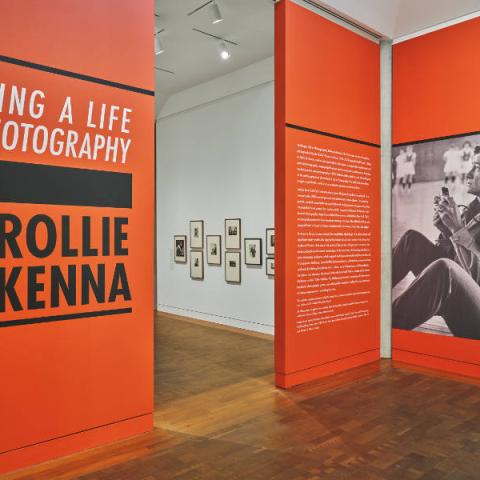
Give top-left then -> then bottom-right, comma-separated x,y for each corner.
0,0 -> 154,90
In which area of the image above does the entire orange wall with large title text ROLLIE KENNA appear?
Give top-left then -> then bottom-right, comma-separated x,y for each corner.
0,0 -> 154,473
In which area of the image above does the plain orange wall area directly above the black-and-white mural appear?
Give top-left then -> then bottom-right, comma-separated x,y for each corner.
392,18 -> 480,144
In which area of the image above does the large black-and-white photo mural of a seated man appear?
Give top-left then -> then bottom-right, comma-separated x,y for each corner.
392,134 -> 480,339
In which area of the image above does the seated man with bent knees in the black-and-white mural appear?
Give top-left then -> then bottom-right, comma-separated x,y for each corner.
392,160 -> 480,339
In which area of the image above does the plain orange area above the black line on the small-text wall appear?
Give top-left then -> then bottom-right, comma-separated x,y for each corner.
285,0 -> 380,143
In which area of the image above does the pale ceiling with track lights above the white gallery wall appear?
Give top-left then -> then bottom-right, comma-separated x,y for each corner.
155,0 -> 274,97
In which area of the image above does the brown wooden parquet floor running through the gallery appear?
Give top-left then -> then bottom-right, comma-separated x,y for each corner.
2,317 -> 480,480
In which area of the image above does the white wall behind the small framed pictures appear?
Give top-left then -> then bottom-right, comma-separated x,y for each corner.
157,58 -> 274,333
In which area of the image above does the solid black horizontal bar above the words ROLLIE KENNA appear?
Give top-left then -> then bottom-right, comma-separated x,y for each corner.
0,160 -> 132,208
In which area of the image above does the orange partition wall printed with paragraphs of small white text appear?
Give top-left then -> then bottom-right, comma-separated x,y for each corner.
275,0 -> 380,388
